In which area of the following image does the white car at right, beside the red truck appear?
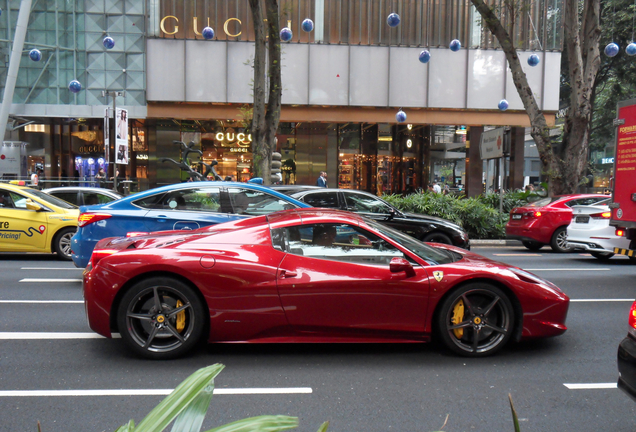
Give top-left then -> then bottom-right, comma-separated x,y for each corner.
567,199 -> 636,261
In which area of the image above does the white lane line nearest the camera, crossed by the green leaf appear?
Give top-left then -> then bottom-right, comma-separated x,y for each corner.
0,387 -> 313,397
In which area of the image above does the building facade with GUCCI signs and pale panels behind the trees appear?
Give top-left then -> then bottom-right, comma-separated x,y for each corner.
0,0 -> 562,194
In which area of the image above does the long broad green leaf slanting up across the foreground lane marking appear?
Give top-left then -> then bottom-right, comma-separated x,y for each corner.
135,364 -> 225,432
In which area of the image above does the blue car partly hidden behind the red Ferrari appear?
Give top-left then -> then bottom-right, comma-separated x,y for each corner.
71,181 -> 311,268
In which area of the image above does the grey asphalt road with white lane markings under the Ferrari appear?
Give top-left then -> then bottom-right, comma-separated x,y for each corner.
0,247 -> 636,432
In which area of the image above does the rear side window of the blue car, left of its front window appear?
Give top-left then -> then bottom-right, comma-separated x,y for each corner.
134,187 -> 221,213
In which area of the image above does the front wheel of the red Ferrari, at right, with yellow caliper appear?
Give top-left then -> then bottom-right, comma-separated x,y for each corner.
437,283 -> 515,357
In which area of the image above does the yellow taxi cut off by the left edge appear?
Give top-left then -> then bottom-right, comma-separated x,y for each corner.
0,183 -> 79,260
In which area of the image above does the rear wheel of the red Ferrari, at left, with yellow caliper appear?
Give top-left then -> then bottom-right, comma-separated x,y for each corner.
117,277 -> 206,360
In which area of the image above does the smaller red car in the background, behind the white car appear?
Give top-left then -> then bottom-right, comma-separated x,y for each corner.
506,194 -> 610,252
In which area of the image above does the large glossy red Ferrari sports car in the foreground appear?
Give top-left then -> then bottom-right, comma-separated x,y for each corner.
84,209 -> 569,358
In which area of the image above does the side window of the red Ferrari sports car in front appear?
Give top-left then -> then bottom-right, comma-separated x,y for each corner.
271,224 -> 408,266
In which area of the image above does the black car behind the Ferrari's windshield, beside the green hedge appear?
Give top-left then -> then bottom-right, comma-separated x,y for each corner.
275,186 -> 470,249
